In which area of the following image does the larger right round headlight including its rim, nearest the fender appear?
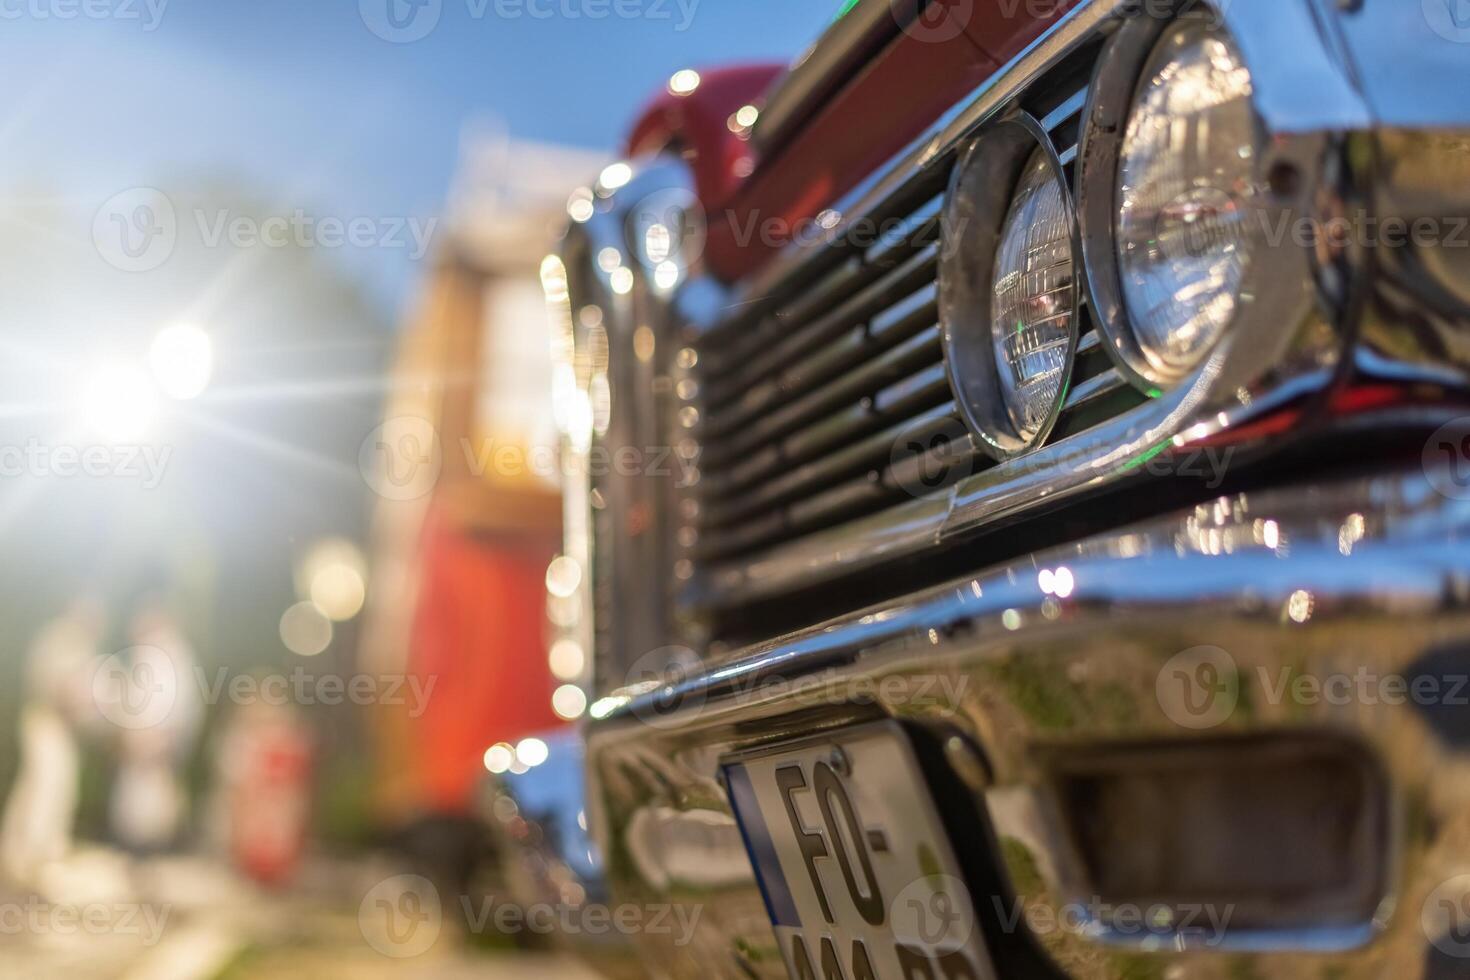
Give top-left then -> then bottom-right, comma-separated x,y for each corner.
1078,10 -> 1282,395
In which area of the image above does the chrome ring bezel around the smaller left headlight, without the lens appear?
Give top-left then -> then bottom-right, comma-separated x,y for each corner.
939,112 -> 1083,460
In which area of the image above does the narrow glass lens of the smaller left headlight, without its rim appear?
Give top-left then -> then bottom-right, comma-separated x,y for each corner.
991,148 -> 1075,442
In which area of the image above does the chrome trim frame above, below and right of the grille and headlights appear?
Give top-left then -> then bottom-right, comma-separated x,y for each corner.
685,0 -> 1372,611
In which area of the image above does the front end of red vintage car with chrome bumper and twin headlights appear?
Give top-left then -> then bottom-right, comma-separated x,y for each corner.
512,0 -> 1470,980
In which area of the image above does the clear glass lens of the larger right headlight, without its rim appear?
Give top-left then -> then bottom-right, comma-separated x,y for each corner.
1116,24 -> 1260,378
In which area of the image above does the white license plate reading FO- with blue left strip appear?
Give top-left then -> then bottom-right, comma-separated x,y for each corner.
723,721 -> 995,980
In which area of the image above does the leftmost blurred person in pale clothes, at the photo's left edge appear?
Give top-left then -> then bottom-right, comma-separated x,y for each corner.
0,597 -> 104,886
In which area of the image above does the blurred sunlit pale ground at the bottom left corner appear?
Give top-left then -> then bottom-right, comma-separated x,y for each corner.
0,851 -> 597,980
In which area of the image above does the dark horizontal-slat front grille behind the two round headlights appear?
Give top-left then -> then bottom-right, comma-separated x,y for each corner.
692,87 -> 1138,575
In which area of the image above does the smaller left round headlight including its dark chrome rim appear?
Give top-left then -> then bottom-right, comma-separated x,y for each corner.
939,113 -> 1080,458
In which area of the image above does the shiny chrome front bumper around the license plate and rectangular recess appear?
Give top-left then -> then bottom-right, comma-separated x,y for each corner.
535,469 -> 1470,979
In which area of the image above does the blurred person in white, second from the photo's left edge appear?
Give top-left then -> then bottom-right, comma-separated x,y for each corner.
109,602 -> 204,855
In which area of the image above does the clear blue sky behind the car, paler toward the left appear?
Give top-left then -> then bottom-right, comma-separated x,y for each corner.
0,0 -> 841,304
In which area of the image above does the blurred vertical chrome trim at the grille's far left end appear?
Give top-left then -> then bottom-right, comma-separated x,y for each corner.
542,159 -> 703,692
